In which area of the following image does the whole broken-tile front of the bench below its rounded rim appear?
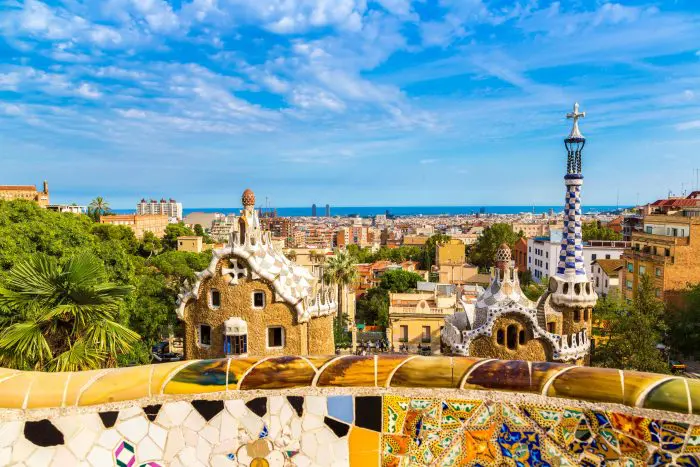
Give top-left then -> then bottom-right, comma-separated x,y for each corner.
0,393 -> 700,467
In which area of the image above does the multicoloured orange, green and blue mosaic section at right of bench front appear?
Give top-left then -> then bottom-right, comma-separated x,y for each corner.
381,396 -> 700,467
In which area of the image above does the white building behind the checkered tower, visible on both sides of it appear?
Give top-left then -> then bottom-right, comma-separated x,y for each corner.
527,229 -> 630,282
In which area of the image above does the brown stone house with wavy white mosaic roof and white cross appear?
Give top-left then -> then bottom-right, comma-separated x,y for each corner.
177,190 -> 337,359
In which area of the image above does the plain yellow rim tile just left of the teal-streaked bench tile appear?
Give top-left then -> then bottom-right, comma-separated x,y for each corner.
78,365 -> 151,406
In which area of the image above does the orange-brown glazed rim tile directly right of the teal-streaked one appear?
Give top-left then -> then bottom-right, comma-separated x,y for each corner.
240,357 -> 316,389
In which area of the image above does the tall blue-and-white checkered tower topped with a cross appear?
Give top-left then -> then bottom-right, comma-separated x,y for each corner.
549,103 -> 598,308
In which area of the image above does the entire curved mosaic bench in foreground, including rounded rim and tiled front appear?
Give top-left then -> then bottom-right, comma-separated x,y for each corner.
0,355 -> 700,467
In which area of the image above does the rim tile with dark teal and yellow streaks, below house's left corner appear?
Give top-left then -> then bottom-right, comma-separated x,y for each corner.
163,358 -> 235,394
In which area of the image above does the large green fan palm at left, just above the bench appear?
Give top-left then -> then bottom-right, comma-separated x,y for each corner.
0,253 -> 140,371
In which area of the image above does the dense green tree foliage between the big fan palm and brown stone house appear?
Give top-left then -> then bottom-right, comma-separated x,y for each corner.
0,201 -> 211,368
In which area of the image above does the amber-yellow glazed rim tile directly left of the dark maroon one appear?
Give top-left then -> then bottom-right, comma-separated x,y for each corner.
390,357 -> 459,388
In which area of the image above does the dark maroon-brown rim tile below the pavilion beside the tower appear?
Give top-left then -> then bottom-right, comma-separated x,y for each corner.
464,360 -> 530,392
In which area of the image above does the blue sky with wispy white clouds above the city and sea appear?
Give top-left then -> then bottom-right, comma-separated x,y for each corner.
0,0 -> 700,208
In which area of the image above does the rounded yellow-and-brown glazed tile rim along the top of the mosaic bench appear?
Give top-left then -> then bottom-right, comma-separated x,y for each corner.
0,355 -> 700,418
